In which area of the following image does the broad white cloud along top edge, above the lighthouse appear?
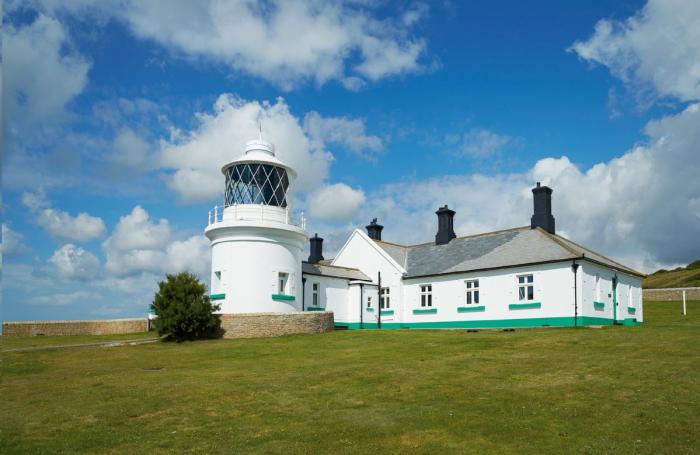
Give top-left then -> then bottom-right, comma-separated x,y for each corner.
16,0 -> 427,90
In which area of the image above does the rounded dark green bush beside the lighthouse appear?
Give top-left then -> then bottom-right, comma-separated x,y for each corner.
151,272 -> 222,342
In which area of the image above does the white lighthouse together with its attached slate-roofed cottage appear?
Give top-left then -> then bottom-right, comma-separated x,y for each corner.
205,140 -> 644,329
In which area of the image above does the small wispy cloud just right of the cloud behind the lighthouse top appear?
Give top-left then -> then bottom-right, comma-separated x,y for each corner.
304,112 -> 383,160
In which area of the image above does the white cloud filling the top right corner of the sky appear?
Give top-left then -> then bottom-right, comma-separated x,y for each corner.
570,0 -> 700,101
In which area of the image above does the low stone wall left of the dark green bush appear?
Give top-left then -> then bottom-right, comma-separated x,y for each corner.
2,318 -> 148,337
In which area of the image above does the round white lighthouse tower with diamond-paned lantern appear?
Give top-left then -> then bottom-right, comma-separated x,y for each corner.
204,135 -> 308,313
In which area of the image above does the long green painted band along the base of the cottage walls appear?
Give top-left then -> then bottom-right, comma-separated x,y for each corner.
335,316 -> 628,329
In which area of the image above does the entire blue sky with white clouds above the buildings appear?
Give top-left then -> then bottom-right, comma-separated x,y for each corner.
0,0 -> 700,320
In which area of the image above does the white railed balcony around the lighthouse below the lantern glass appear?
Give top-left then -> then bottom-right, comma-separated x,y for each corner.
208,204 -> 306,230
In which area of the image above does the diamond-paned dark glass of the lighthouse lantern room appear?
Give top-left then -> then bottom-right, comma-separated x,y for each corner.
224,163 -> 289,207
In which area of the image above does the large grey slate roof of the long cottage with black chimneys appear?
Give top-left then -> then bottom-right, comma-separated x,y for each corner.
376,226 -> 642,278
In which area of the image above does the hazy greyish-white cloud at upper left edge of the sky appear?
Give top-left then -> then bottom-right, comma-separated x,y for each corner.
2,14 -> 90,124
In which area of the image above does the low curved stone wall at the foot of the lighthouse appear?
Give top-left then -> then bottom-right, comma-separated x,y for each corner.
221,311 -> 333,338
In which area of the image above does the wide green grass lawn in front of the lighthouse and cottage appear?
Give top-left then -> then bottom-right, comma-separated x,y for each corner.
0,302 -> 700,454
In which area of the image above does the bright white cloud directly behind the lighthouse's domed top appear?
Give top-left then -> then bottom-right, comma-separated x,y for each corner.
161,95 -> 333,202
